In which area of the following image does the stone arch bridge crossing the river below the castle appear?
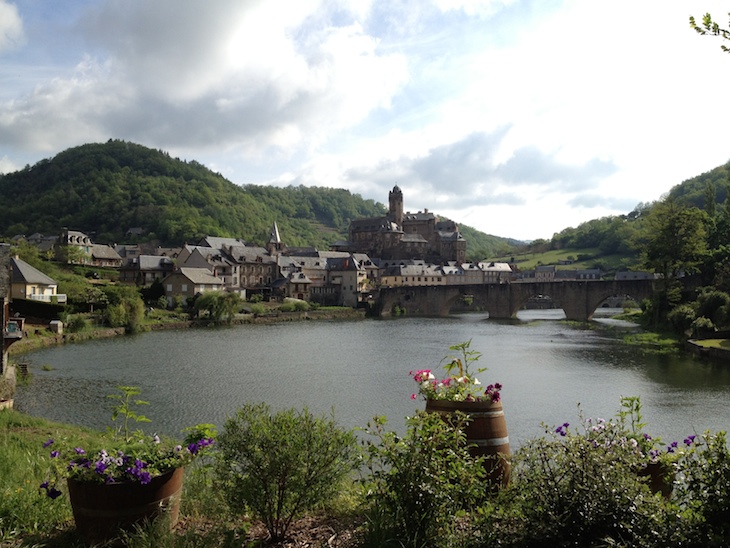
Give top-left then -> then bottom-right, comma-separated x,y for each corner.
378,280 -> 654,321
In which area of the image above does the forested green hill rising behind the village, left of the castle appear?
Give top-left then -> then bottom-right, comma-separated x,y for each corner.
0,140 -> 511,258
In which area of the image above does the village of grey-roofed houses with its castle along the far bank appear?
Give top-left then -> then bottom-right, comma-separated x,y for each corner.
4,186 -> 640,308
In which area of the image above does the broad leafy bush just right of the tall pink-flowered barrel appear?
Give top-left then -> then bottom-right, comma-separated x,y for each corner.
482,408 -> 673,546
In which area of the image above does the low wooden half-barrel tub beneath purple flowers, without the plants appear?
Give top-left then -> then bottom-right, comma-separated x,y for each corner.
68,468 -> 185,544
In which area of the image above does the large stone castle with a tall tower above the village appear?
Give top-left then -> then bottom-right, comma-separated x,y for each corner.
349,185 -> 466,264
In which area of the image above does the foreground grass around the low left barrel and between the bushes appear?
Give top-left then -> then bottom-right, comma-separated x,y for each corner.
0,409 -> 358,548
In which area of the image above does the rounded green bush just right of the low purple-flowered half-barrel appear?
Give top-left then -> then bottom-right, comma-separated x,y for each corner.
217,403 -> 357,541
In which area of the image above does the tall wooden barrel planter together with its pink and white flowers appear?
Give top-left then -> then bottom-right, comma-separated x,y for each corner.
410,340 -> 510,485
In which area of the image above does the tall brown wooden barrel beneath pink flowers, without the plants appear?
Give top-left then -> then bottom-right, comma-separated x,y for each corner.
426,400 -> 510,487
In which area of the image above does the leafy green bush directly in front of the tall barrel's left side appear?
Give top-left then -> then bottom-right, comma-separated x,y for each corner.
362,411 -> 486,547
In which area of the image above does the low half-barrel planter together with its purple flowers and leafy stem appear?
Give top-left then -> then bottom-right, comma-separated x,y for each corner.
40,386 -> 215,543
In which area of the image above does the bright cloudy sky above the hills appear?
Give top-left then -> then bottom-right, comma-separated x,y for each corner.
0,0 -> 730,240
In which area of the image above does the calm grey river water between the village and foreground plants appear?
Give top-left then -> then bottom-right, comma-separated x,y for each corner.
15,311 -> 730,446
